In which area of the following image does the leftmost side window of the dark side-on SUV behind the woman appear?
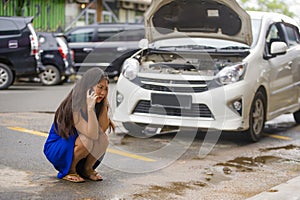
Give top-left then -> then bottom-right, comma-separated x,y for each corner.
68,28 -> 94,42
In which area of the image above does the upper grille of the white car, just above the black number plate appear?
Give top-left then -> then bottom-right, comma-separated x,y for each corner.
139,78 -> 208,93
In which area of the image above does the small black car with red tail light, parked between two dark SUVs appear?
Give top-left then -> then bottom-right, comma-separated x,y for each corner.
37,32 -> 75,85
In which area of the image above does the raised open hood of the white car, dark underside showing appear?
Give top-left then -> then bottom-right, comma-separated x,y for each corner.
145,0 -> 252,45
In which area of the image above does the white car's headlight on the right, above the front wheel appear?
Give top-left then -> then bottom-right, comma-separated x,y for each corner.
216,63 -> 247,85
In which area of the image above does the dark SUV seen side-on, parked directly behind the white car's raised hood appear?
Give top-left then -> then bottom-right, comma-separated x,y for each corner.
65,23 -> 144,77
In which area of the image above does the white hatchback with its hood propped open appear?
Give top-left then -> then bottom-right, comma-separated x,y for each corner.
114,0 -> 300,141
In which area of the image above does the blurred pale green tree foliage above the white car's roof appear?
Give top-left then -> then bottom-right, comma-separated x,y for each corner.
238,0 -> 295,17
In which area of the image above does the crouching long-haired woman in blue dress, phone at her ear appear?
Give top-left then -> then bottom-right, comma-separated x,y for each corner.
44,68 -> 114,182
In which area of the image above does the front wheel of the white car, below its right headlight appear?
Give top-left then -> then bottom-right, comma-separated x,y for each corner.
246,91 -> 266,142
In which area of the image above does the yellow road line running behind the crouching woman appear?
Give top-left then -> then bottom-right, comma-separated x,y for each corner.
7,127 -> 156,162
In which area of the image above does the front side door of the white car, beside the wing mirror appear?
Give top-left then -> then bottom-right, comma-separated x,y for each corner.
266,23 -> 298,115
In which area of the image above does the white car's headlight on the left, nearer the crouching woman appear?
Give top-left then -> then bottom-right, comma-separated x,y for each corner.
123,58 -> 140,80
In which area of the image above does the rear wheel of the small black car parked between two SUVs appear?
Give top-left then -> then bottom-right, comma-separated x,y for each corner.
39,65 -> 61,85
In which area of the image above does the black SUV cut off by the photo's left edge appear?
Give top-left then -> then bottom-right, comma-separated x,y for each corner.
0,17 -> 43,89
